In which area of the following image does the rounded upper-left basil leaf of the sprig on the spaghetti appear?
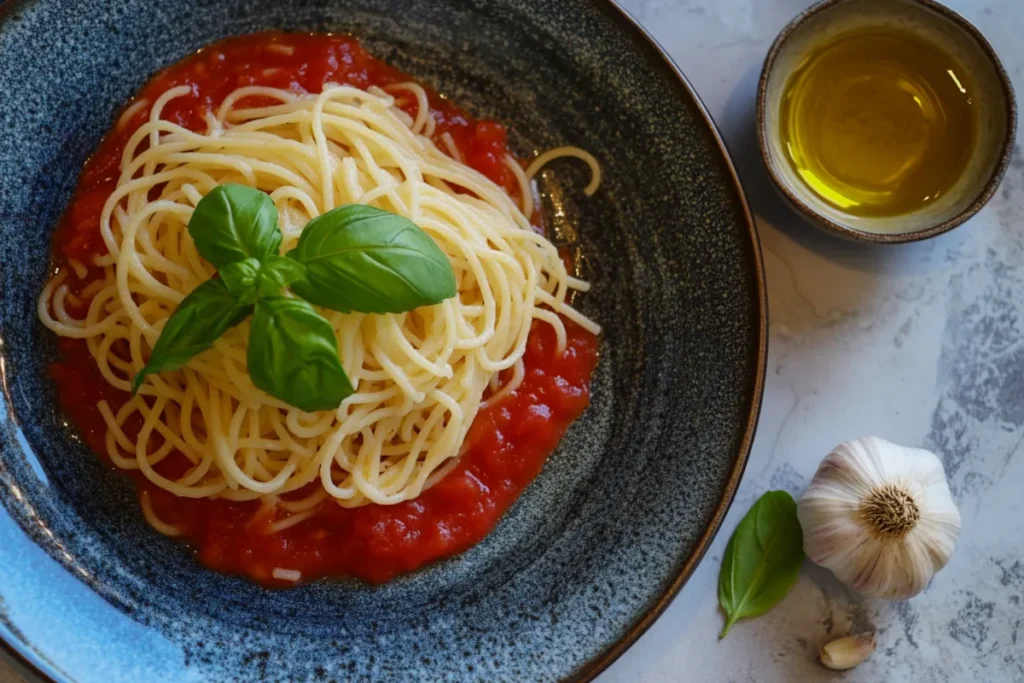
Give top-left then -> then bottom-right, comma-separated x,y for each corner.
188,183 -> 281,268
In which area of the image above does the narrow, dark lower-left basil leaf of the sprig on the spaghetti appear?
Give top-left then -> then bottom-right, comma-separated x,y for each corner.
131,279 -> 252,394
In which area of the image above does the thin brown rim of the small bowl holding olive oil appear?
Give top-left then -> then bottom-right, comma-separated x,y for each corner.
756,0 -> 1017,245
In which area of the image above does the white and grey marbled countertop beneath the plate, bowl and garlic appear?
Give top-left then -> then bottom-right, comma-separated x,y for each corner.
0,0 -> 1024,683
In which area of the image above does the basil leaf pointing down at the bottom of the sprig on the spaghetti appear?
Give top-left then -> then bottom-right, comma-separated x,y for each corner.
248,297 -> 353,413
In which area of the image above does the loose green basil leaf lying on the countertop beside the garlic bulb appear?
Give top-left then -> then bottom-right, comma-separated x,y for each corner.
718,490 -> 804,638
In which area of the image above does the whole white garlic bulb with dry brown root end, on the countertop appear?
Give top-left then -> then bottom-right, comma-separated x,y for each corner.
797,436 -> 961,600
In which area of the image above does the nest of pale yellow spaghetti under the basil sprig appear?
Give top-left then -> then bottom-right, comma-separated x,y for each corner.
39,83 -> 599,523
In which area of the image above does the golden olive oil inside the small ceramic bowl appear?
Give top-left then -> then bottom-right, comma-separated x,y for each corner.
780,28 -> 977,216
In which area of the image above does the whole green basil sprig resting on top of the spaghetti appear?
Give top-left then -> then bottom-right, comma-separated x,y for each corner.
132,184 -> 456,412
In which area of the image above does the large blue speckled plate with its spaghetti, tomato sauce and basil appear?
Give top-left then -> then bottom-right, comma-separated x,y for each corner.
0,0 -> 766,682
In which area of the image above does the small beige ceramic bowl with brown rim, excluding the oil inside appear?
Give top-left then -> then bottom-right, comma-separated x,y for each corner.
758,0 -> 1017,244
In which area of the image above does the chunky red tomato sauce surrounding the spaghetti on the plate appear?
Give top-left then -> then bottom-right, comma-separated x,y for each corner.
51,33 -> 597,587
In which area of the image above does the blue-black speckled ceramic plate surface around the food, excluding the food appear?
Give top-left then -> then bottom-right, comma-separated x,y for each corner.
0,0 -> 765,683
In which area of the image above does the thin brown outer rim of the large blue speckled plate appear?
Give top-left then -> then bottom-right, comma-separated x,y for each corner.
0,0 -> 770,683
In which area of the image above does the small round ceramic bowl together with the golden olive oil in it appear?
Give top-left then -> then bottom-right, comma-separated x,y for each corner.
758,0 -> 1017,243
